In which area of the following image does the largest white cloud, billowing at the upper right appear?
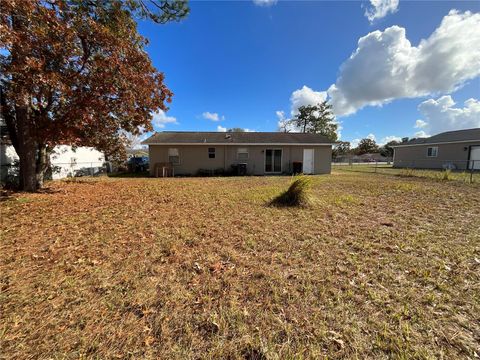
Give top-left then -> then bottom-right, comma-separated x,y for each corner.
328,10 -> 480,116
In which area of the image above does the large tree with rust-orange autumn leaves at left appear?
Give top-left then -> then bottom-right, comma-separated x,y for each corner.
0,0 -> 188,191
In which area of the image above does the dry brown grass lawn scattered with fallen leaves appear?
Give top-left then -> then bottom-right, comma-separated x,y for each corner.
0,171 -> 480,359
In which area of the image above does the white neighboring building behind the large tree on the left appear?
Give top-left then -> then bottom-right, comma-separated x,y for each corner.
0,144 -> 105,182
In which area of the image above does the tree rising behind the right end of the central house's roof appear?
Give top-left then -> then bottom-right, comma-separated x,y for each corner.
292,101 -> 338,141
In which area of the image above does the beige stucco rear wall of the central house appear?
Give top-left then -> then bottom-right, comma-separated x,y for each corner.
149,145 -> 332,175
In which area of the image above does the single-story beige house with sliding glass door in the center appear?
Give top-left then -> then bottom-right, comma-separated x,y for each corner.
142,131 -> 334,176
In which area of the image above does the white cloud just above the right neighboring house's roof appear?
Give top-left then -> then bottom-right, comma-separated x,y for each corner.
415,95 -> 480,137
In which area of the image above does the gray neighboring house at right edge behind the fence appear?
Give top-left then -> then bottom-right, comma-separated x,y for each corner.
392,128 -> 480,170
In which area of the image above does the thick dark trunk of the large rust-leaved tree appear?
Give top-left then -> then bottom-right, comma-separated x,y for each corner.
15,105 -> 37,192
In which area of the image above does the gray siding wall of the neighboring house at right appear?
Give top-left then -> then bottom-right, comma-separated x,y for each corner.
393,141 -> 480,169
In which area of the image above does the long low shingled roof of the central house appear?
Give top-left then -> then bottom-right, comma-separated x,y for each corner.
142,131 -> 334,145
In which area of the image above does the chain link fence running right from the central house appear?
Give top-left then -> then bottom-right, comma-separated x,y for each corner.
332,159 -> 480,183
